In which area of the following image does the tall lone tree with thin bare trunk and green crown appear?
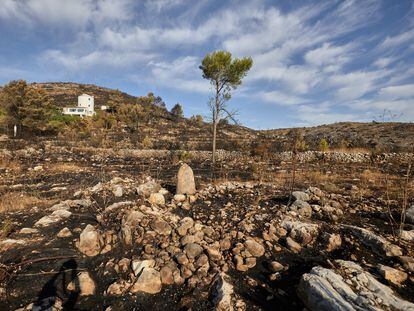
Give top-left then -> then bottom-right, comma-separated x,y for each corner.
200,51 -> 253,165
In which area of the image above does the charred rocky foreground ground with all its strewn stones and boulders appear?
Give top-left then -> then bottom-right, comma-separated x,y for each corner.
0,145 -> 414,310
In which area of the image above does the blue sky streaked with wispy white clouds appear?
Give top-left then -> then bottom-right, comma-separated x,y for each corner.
0,0 -> 414,129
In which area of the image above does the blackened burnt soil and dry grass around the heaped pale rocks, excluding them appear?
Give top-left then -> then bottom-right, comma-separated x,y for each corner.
0,142 -> 414,310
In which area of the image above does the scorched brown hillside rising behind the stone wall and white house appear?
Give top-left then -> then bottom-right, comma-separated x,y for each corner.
0,82 -> 414,152
